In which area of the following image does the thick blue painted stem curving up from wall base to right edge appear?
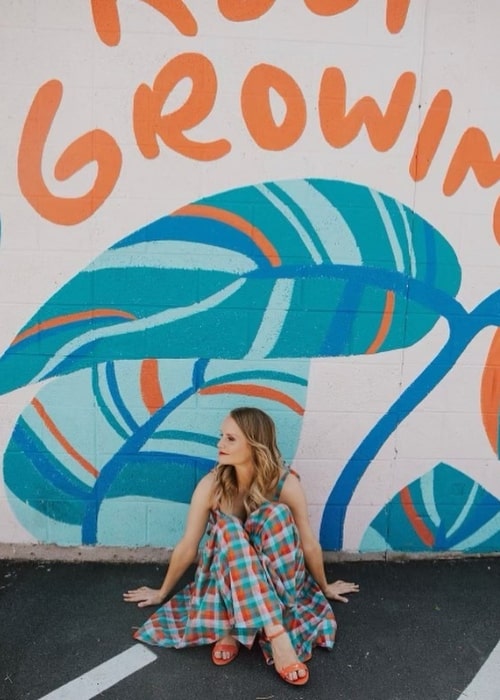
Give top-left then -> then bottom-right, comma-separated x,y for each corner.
321,291 -> 500,550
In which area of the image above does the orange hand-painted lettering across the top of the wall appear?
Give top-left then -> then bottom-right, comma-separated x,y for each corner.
18,0 -> 500,243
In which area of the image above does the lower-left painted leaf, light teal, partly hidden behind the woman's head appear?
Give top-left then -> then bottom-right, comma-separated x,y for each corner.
4,359 -> 309,546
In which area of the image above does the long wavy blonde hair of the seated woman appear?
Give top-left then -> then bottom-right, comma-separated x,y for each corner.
214,406 -> 284,515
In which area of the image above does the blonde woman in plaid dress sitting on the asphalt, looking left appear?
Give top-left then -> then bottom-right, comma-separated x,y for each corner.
123,407 -> 358,685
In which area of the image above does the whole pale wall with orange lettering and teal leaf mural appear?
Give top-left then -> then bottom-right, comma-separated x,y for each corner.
0,0 -> 500,552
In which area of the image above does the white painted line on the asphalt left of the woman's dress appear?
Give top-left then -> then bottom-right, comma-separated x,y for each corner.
40,644 -> 157,700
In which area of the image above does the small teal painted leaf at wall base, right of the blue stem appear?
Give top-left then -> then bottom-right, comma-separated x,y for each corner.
360,464 -> 500,553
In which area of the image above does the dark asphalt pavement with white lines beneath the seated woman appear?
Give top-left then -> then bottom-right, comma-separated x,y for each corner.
0,557 -> 500,700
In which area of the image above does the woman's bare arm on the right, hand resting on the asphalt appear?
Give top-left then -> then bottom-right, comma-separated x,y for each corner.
280,474 -> 359,603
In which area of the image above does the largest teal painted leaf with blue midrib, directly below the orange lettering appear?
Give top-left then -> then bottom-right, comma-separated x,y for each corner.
0,179 -> 460,393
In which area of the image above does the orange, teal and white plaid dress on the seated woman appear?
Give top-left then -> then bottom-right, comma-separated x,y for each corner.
134,472 -> 336,663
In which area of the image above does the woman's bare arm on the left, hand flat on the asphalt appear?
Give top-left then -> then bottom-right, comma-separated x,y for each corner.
123,473 -> 213,608
